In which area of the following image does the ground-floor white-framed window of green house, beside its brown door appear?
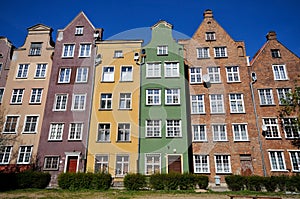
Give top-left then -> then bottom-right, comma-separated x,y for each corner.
145,153 -> 161,175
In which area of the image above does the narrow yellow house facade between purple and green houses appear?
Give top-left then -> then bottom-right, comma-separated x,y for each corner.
87,40 -> 142,182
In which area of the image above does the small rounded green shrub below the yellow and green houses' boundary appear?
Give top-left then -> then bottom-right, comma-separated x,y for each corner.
124,173 -> 146,190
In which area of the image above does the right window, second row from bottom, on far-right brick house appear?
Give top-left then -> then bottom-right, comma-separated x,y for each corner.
282,118 -> 300,139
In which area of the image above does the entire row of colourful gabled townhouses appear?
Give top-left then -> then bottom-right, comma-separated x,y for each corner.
0,10 -> 300,186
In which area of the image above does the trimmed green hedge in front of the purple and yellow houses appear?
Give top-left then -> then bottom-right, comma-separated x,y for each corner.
58,173 -> 112,190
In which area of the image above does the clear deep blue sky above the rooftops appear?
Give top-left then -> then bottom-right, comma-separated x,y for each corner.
0,0 -> 300,57
